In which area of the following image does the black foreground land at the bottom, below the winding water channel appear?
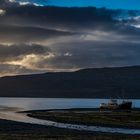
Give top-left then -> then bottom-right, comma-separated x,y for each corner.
0,120 -> 140,140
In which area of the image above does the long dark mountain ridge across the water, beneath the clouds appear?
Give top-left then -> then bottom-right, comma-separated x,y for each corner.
0,66 -> 140,98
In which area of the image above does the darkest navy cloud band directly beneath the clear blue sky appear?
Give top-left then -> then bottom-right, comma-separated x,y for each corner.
1,6 -> 118,29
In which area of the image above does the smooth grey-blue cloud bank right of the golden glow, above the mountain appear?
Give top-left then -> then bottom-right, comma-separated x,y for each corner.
46,41 -> 140,70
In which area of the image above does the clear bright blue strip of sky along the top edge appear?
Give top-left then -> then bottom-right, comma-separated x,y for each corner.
16,0 -> 140,10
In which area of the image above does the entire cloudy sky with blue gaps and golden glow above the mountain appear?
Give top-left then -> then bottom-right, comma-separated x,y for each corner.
0,0 -> 140,76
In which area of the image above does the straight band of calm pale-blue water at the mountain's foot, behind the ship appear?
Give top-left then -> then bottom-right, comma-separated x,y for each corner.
0,98 -> 140,110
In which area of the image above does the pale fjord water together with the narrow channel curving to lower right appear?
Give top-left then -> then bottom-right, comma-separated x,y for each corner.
0,98 -> 140,135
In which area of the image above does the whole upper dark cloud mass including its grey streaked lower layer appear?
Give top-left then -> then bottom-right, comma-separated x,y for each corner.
0,5 -> 140,42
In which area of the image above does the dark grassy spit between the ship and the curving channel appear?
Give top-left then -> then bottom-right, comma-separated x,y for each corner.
28,111 -> 140,128
